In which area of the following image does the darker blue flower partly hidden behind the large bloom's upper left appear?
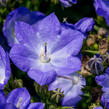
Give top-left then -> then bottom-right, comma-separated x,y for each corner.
3,7 -> 45,47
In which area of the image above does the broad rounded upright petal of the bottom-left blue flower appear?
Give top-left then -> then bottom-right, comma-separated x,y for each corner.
6,88 -> 30,109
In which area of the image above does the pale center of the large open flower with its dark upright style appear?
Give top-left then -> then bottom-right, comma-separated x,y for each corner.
40,43 -> 51,63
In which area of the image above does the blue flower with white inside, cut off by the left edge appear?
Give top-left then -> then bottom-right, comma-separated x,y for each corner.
0,46 -> 11,89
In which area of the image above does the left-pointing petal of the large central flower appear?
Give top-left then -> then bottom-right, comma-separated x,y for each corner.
10,44 -> 37,72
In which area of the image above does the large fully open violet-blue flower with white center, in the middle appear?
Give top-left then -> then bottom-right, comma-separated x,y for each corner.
10,13 -> 84,85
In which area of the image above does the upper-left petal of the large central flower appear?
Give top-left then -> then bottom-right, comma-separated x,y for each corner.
15,21 -> 38,48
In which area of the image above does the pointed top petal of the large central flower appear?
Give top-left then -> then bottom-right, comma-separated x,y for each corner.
37,13 -> 60,42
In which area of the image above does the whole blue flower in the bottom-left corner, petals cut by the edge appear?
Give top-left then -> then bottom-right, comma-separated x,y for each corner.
0,88 -> 44,109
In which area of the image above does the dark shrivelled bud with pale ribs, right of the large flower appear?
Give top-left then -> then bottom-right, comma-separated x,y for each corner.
88,55 -> 104,74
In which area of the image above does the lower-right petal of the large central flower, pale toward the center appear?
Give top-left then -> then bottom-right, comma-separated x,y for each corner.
51,56 -> 81,75
